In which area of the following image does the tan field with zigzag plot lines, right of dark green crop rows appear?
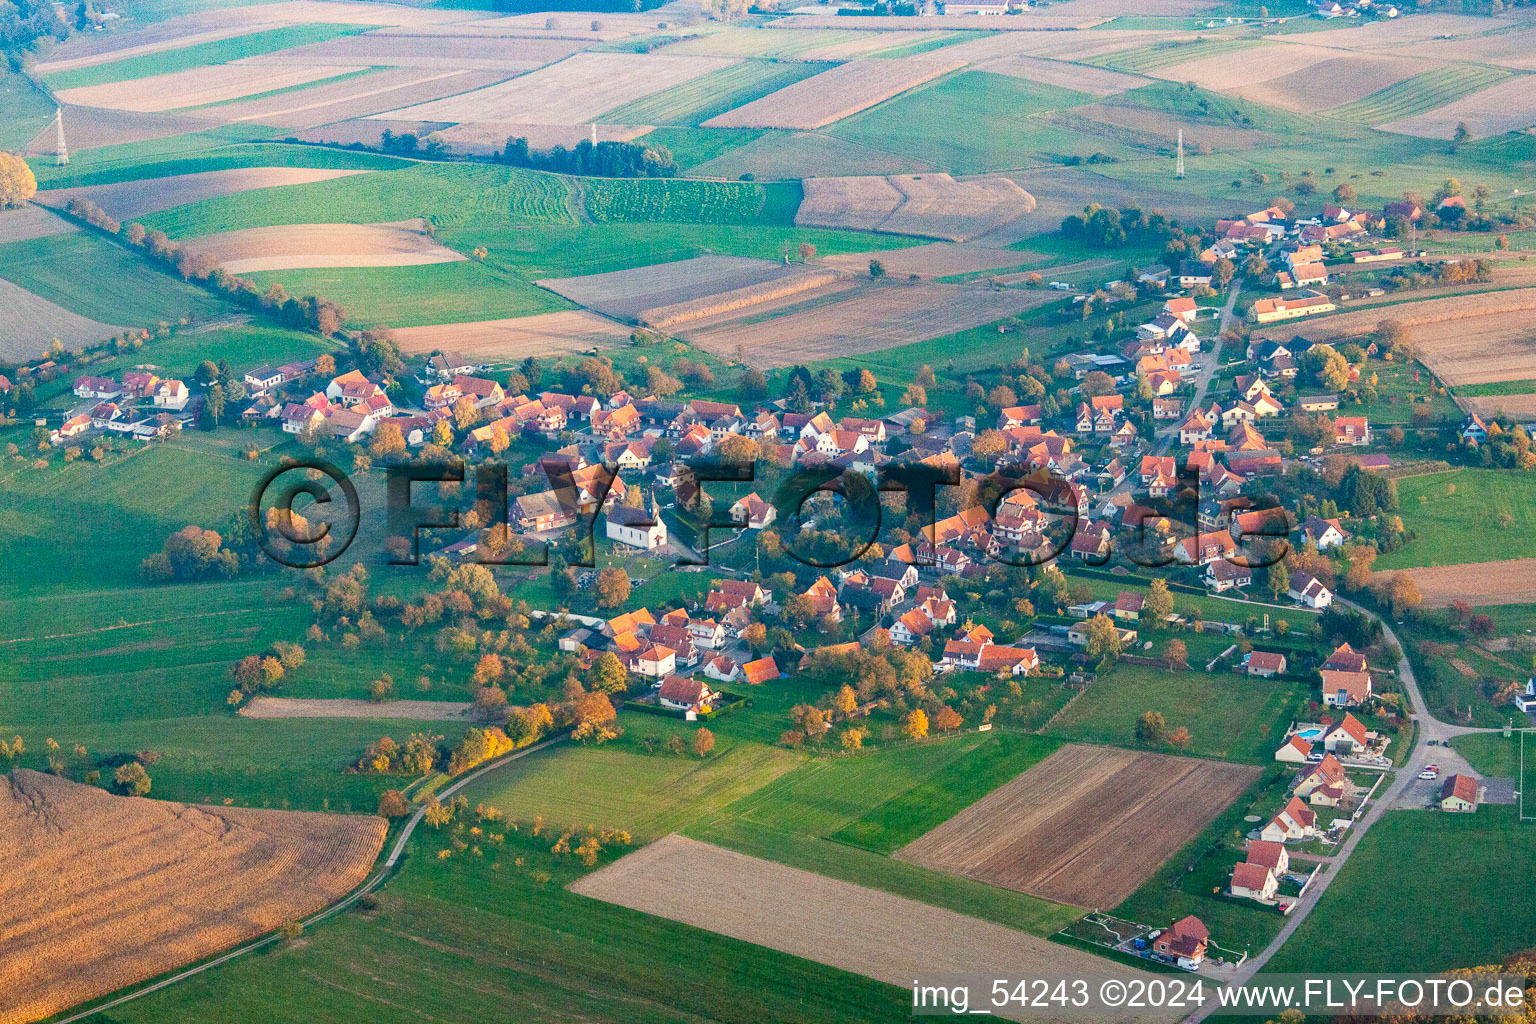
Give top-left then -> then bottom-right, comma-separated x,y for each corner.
794,173 -> 1035,244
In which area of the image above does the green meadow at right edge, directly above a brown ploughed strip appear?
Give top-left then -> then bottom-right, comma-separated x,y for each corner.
1375,470 -> 1536,571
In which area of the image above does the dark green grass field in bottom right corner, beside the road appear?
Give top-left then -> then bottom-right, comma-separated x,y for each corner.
1267,806 -> 1536,972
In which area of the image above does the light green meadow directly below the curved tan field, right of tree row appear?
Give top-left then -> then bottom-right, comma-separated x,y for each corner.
244,259 -> 571,327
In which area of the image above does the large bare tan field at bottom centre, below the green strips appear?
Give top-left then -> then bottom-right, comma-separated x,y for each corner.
571,834 -> 1146,1019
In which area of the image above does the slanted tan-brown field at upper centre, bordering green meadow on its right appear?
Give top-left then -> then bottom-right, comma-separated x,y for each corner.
703,57 -> 963,129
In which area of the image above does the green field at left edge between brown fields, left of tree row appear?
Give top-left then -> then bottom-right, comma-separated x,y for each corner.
0,232 -> 233,327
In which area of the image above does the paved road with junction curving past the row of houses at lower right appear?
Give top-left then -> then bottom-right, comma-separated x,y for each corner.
1184,597 -> 1491,1024
